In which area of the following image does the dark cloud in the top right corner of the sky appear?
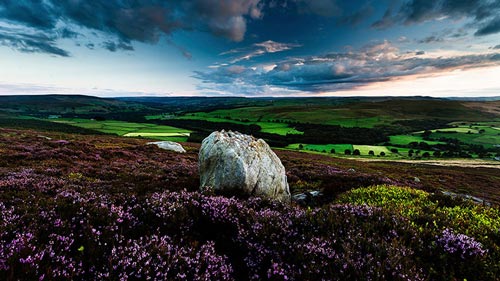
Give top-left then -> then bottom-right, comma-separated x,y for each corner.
372,0 -> 500,36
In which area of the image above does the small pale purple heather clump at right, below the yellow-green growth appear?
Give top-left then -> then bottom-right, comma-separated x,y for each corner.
436,228 -> 487,260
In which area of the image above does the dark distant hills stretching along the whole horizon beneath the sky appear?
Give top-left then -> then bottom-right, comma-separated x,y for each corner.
0,95 -> 500,123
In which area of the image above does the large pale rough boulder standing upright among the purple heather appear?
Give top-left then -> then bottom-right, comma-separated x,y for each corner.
198,130 -> 290,202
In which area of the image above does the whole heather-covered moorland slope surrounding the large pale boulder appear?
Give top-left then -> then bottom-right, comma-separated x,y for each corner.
0,129 -> 500,280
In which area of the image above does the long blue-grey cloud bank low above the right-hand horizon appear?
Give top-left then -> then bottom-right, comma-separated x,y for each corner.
194,42 -> 500,93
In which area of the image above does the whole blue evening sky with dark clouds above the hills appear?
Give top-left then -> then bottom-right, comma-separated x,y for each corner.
0,0 -> 500,97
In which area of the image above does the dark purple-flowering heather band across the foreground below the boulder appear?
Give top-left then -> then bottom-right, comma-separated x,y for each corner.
0,183 -> 494,280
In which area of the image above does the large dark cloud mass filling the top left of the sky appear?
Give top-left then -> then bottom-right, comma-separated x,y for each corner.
0,0 -> 263,55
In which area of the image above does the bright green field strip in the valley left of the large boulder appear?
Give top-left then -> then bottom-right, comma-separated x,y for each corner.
50,118 -> 191,141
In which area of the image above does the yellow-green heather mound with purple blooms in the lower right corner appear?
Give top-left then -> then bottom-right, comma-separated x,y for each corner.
338,186 -> 500,279
